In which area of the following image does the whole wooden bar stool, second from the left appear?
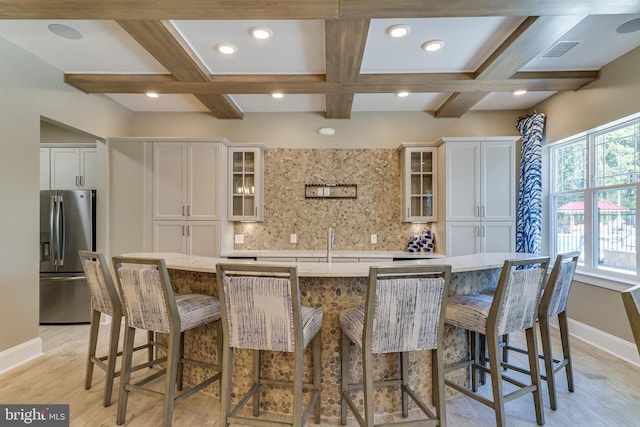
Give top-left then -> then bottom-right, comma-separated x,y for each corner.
113,256 -> 220,426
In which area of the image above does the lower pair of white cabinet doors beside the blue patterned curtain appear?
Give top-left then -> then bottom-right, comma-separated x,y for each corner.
446,221 -> 515,256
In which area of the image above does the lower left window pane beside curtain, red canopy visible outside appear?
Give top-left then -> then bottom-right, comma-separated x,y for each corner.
554,193 -> 584,261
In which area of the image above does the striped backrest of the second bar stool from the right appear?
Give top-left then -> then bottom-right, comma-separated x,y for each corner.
487,257 -> 549,335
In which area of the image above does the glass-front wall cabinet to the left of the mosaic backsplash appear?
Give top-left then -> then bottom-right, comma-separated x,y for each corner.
227,144 -> 264,221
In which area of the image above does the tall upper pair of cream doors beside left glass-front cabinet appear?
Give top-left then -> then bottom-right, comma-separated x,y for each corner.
153,141 -> 221,221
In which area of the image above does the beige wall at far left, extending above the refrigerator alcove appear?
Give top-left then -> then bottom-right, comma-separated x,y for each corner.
0,38 -> 131,364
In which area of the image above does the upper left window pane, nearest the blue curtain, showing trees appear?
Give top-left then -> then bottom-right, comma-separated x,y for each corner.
553,139 -> 587,192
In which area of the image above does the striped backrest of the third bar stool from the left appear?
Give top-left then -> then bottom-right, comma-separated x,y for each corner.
220,265 -> 303,352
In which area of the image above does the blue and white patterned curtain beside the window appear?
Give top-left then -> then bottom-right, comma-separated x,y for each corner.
516,113 -> 545,254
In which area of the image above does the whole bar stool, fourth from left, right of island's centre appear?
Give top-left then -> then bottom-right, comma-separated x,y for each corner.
340,265 -> 451,427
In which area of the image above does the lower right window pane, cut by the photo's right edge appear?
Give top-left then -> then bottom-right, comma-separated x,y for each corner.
594,187 -> 636,273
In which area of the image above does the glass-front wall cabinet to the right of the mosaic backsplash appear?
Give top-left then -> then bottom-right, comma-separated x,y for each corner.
400,143 -> 438,223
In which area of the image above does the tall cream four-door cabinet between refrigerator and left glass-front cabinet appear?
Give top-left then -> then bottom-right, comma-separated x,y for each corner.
153,141 -> 224,257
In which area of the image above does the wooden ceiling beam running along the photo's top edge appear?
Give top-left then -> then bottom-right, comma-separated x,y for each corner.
0,0 -> 640,20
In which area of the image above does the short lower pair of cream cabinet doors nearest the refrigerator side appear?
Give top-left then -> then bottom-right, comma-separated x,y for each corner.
153,221 -> 220,258
